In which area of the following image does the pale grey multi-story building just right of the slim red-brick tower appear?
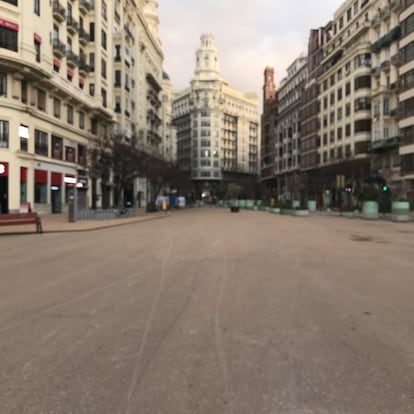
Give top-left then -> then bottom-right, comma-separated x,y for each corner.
275,56 -> 308,200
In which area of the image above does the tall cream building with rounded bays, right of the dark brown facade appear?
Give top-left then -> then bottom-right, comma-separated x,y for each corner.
318,0 -> 373,206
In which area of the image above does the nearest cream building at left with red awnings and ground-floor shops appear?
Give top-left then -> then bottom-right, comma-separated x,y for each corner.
0,0 -> 113,213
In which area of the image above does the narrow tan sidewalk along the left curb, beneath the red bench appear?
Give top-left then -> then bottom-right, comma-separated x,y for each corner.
0,208 -> 170,236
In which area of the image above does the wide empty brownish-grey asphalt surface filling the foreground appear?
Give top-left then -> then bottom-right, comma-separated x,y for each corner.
0,208 -> 414,414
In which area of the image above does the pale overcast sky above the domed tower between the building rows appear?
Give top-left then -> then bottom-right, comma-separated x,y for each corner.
158,0 -> 344,100
